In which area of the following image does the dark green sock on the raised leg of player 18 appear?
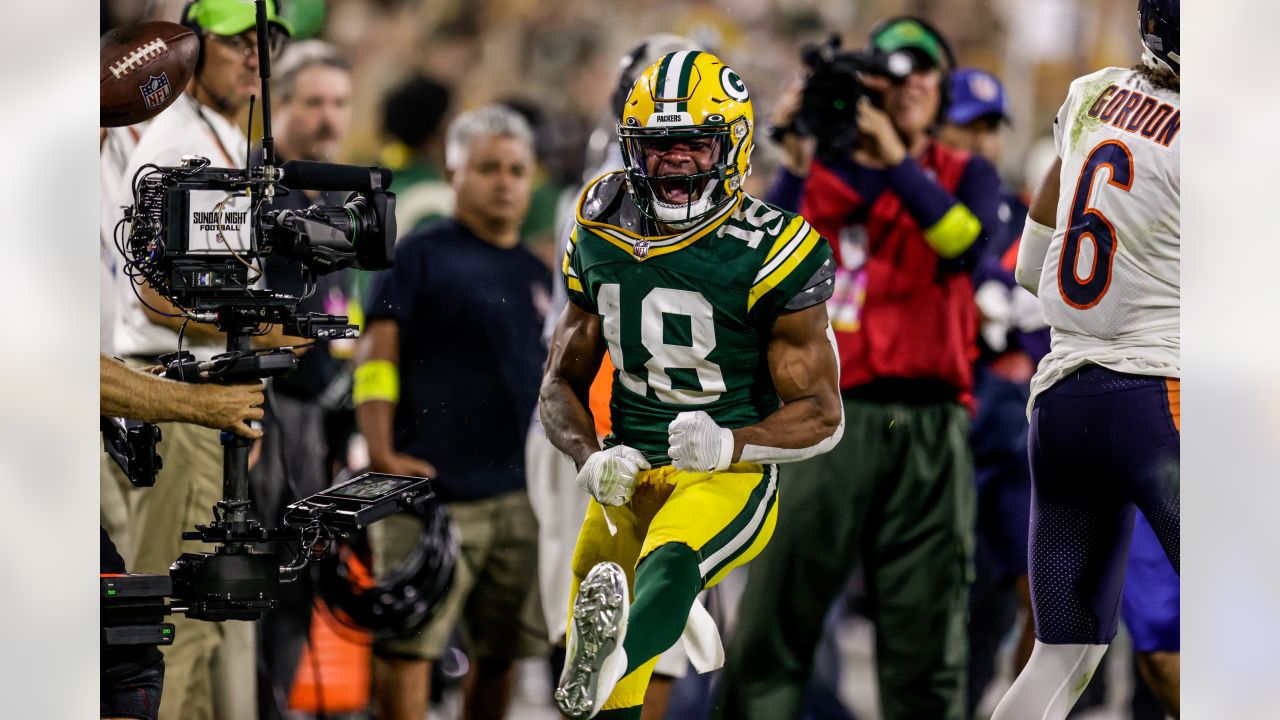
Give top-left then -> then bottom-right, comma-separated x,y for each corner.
619,542 -> 703,676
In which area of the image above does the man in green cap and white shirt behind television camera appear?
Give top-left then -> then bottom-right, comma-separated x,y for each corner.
114,0 -> 291,719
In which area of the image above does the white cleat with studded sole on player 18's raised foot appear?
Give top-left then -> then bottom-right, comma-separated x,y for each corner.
556,562 -> 631,720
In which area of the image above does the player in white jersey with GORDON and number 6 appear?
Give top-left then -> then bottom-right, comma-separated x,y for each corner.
992,0 -> 1181,720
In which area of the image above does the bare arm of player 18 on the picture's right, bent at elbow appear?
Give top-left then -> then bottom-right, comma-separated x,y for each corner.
733,304 -> 844,462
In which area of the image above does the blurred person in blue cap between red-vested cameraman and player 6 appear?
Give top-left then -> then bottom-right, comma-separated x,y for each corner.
940,68 -> 1048,715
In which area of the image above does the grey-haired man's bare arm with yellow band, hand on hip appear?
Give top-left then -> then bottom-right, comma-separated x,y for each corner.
355,315 -> 435,477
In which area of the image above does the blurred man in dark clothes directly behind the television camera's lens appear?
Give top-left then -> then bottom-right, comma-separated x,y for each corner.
250,40 -> 351,720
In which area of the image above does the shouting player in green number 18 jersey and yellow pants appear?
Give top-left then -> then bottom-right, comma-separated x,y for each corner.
540,51 -> 844,720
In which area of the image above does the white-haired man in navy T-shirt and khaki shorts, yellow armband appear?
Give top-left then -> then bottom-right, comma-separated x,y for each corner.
353,105 -> 550,720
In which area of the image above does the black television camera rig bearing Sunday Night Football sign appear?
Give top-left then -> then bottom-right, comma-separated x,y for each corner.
100,0 -> 445,644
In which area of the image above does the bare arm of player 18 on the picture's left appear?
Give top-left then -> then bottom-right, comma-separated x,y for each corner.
538,302 -> 604,469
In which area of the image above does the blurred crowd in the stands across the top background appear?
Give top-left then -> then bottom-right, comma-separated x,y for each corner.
101,0 -> 1134,263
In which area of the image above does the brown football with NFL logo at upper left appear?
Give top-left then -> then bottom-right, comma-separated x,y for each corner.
100,20 -> 200,128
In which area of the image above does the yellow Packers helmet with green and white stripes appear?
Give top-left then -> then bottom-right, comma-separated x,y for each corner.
618,50 -> 755,227
